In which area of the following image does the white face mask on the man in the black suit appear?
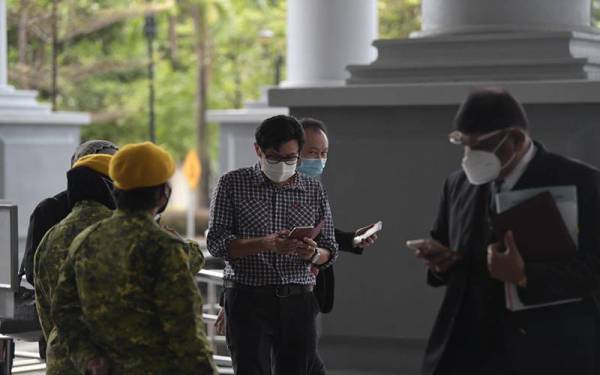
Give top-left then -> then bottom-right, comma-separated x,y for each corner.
462,134 -> 515,185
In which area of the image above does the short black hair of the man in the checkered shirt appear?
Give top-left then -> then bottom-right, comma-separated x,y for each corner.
254,115 -> 304,151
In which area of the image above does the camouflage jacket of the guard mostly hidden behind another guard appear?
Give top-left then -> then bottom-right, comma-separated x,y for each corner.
34,200 -> 112,375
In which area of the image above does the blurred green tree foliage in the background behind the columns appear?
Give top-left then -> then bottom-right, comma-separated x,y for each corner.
8,0 -> 600,164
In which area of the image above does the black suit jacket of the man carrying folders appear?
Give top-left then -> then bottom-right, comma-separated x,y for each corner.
422,144 -> 600,375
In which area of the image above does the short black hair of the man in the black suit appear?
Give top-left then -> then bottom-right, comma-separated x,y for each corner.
454,87 -> 529,134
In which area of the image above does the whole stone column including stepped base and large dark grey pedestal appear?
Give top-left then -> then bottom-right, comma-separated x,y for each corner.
269,0 -> 600,374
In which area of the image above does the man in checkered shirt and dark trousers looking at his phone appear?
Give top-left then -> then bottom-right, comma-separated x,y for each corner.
207,115 -> 338,375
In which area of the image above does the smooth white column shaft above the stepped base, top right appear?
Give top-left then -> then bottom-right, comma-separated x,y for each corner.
417,0 -> 591,35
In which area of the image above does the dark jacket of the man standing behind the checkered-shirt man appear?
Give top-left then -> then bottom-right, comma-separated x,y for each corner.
314,229 -> 363,314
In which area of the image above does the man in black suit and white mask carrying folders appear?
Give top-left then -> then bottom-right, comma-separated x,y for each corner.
413,88 -> 600,375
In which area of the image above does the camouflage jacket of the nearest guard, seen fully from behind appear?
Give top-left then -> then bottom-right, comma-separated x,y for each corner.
52,210 -> 217,375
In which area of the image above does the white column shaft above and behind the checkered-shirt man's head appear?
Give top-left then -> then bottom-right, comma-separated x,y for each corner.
282,0 -> 378,87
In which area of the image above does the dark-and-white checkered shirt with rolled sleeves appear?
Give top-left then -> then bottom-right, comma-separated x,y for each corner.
207,165 -> 338,286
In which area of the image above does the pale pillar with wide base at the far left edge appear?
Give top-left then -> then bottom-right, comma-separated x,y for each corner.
0,0 -> 90,262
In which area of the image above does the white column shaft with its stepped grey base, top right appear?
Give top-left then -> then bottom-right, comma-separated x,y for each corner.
346,0 -> 600,84
